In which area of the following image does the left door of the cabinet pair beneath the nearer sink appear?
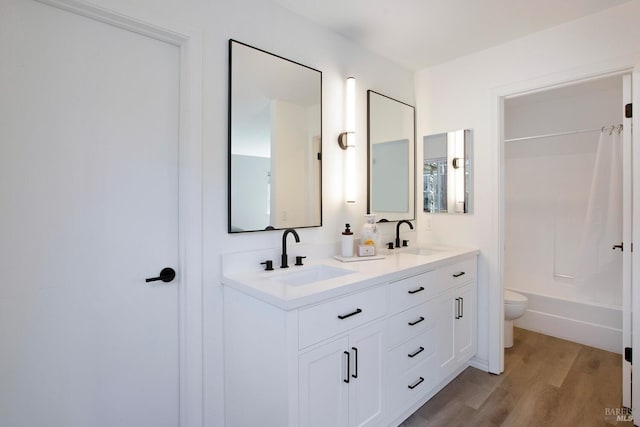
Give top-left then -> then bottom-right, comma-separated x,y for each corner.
298,337 -> 353,427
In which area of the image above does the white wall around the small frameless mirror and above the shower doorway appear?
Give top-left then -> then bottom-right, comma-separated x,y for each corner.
416,1 -> 640,371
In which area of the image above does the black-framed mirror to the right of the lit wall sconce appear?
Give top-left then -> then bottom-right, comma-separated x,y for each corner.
367,90 -> 415,221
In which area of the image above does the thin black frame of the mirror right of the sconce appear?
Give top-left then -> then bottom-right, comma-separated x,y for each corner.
367,90 -> 417,222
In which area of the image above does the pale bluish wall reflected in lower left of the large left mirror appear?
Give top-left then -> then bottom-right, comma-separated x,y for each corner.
231,154 -> 271,231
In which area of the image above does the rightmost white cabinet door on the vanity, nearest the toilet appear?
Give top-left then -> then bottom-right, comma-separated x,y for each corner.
454,283 -> 476,366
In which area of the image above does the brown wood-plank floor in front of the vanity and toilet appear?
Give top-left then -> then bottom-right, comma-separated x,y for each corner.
401,328 -> 633,427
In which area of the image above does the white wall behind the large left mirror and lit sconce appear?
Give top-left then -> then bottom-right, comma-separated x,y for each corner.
63,0 -> 414,426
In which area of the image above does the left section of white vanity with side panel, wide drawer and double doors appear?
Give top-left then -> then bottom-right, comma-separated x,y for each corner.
224,285 -> 387,427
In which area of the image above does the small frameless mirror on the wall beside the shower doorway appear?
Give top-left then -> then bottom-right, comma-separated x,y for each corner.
422,129 -> 473,213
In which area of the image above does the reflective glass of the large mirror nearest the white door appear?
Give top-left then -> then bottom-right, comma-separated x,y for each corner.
228,40 -> 322,233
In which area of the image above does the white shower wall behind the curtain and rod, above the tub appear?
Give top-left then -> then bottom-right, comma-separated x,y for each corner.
504,76 -> 622,306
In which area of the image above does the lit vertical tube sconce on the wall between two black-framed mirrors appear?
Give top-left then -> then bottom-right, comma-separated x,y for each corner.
338,77 -> 356,203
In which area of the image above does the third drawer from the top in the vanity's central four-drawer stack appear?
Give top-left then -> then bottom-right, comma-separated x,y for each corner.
388,328 -> 437,378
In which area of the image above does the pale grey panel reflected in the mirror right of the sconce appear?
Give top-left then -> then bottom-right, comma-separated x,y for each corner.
371,139 -> 409,212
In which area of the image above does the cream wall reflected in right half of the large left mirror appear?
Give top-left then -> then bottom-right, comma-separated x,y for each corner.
271,101 -> 310,228
